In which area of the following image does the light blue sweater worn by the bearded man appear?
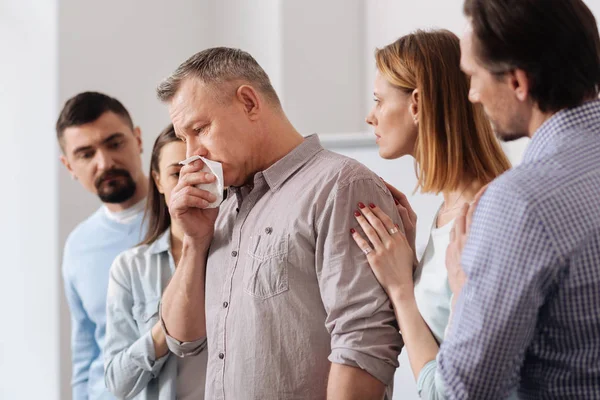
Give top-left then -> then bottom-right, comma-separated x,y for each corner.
62,207 -> 143,400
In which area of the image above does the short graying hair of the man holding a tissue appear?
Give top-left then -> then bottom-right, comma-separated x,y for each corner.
156,47 -> 281,106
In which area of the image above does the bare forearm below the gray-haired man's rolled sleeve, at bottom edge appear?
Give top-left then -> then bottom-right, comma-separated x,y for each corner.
327,363 -> 385,400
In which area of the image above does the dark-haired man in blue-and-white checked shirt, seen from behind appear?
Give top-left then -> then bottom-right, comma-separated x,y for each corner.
436,0 -> 600,399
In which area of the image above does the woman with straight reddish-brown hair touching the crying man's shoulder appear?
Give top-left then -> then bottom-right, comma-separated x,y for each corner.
351,30 -> 510,398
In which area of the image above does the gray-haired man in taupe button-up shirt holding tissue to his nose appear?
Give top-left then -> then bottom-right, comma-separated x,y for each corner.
157,48 -> 402,400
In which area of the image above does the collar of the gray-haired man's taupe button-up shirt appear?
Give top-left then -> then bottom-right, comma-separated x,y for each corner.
227,134 -> 323,197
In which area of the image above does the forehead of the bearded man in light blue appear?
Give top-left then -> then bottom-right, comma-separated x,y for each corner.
62,111 -> 132,153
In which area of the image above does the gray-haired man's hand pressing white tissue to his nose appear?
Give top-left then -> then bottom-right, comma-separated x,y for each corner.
169,160 -> 219,247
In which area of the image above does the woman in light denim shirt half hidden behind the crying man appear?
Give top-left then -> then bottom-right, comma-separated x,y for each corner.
104,125 -> 207,400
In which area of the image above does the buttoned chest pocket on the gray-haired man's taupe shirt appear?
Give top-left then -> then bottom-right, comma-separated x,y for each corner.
244,234 -> 289,300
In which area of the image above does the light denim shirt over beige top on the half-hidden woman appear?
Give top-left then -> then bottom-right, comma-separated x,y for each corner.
104,229 -> 208,400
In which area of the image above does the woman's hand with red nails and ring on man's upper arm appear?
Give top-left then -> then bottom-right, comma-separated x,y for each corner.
350,203 -> 415,297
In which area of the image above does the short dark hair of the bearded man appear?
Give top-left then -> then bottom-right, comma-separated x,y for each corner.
56,92 -> 133,150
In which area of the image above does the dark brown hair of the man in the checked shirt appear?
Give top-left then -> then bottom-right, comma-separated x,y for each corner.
463,0 -> 600,112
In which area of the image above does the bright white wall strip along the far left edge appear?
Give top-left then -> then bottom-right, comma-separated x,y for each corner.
0,0 -> 60,400
